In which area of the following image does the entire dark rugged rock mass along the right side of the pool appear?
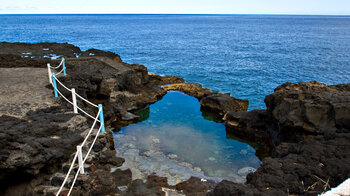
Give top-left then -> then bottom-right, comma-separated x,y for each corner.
216,82 -> 350,195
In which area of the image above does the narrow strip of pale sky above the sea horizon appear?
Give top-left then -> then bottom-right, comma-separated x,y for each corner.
0,0 -> 350,15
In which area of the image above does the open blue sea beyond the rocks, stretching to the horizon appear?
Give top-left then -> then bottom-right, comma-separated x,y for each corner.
0,15 -> 350,110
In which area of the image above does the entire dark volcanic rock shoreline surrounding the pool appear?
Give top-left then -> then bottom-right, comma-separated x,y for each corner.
0,43 -> 350,195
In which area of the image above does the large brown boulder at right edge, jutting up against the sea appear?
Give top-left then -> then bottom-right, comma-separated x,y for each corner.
265,81 -> 350,134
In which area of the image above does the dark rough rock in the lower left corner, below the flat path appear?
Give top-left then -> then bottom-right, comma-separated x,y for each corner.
0,107 -> 88,194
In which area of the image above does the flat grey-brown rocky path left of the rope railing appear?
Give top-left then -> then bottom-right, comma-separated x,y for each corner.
0,68 -> 58,117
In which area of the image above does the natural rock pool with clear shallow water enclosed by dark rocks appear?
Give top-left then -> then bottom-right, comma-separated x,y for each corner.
114,92 -> 261,184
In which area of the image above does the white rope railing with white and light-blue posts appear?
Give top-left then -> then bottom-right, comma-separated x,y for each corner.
47,58 -> 105,196
